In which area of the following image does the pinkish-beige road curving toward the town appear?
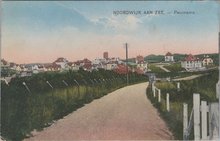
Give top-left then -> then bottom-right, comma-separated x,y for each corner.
25,82 -> 172,141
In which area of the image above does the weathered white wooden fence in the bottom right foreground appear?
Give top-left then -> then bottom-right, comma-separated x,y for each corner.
183,93 -> 219,140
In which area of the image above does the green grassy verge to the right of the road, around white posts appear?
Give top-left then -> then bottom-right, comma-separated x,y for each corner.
147,70 -> 218,140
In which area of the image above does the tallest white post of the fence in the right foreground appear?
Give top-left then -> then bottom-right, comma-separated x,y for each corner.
193,93 -> 200,140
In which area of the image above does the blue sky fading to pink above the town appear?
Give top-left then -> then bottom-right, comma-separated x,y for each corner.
1,1 -> 220,63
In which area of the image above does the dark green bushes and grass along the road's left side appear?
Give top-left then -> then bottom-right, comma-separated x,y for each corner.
1,70 -> 146,141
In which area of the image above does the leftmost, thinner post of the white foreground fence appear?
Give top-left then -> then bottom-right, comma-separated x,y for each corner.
183,103 -> 188,140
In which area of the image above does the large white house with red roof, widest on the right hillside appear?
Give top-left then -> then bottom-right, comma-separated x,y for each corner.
181,54 -> 204,71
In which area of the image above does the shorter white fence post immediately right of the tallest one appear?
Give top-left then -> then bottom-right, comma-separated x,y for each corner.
201,101 -> 208,140
